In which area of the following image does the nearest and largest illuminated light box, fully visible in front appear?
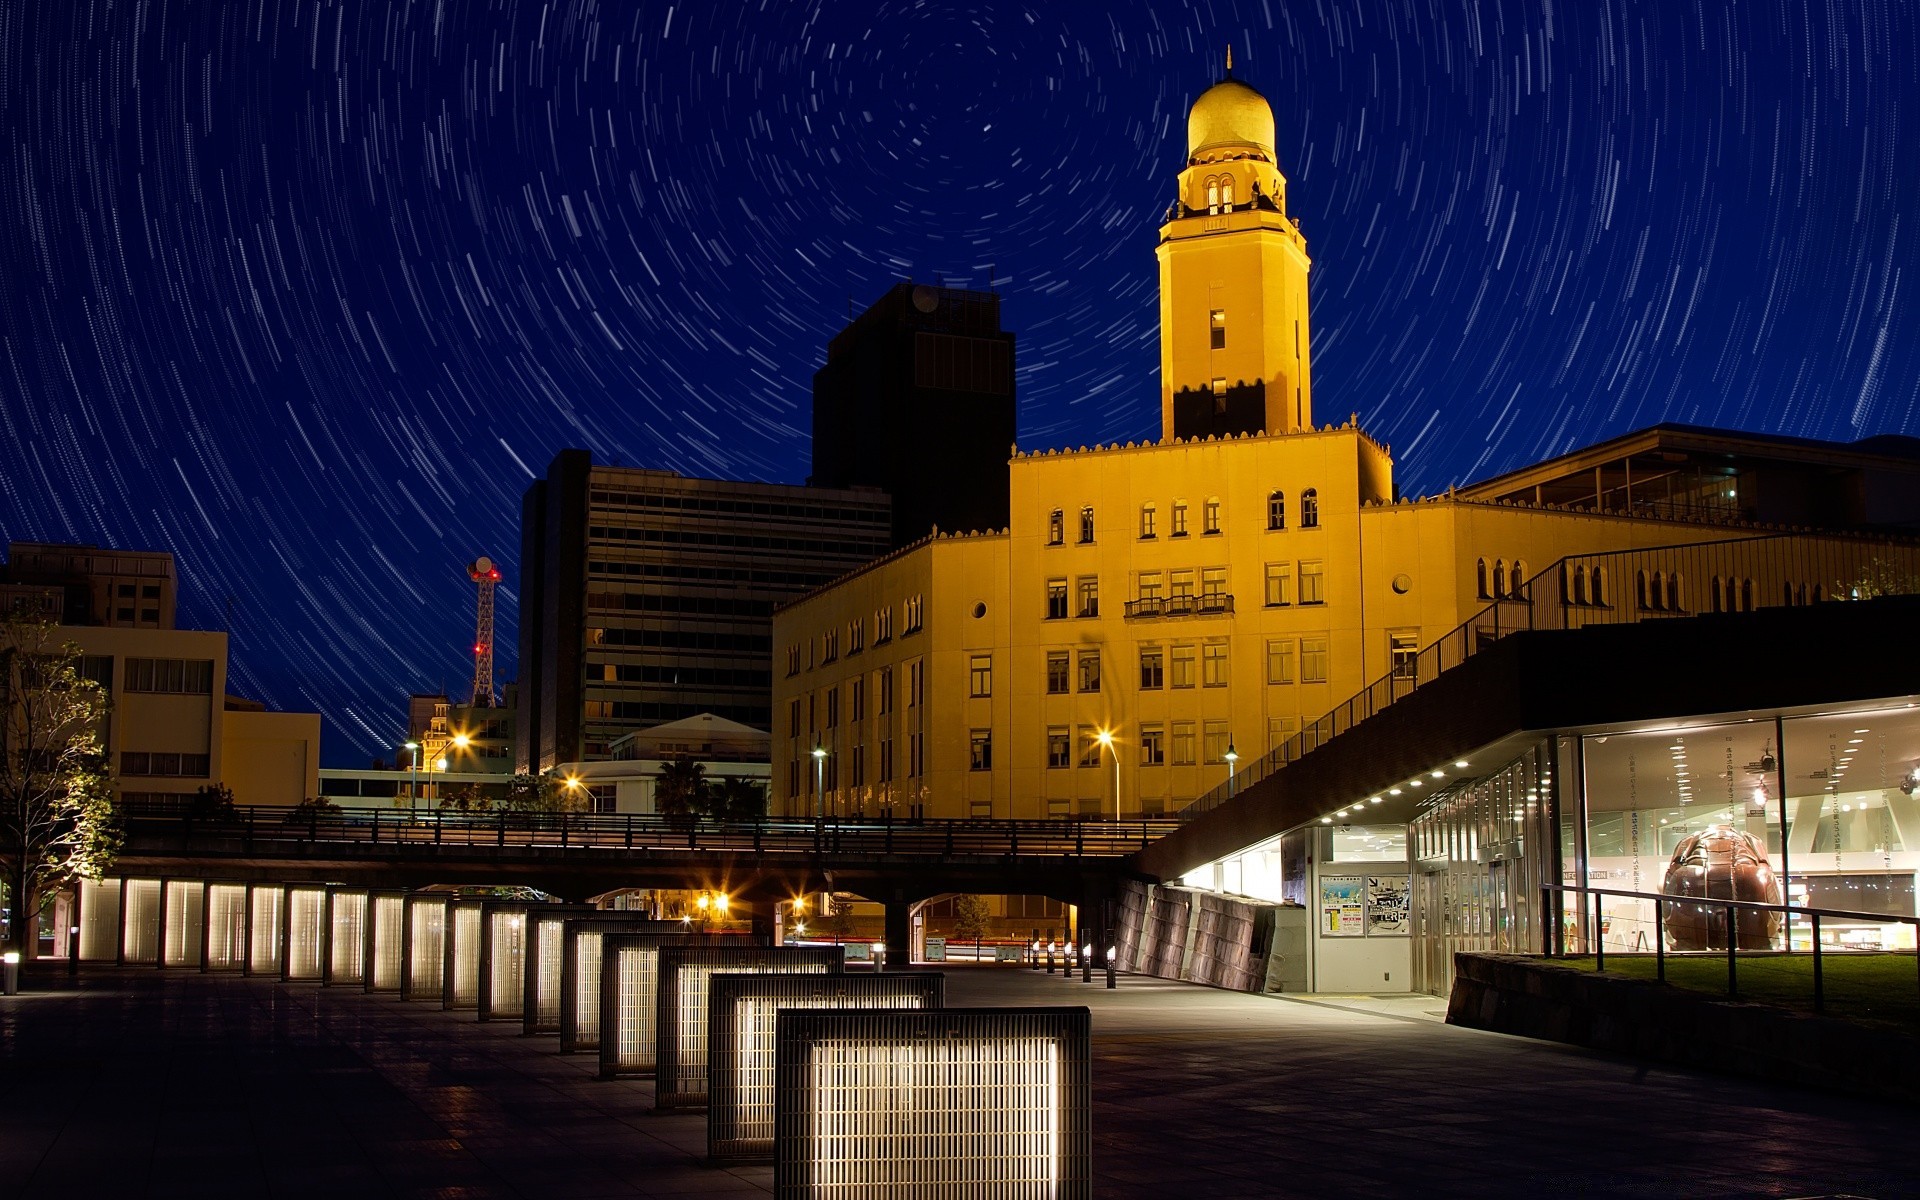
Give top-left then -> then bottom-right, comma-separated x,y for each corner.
774,1008 -> 1092,1200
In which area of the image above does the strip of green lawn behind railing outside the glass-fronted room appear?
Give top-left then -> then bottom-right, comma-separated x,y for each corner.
1553,954 -> 1920,1027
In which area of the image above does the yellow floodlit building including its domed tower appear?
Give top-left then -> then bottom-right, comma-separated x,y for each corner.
772,63 -> 1884,818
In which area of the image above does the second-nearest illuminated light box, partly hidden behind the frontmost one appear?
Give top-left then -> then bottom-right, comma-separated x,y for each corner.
707,972 -> 947,1162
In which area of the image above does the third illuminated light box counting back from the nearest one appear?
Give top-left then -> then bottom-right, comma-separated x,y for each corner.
653,947 -> 845,1108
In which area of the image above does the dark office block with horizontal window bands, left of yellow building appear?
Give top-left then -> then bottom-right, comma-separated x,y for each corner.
515,449 -> 890,772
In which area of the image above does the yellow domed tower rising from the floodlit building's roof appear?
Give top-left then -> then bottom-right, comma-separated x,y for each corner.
1158,56 -> 1313,438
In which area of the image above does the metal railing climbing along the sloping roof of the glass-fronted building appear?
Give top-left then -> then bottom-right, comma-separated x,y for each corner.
1179,534 -> 1920,822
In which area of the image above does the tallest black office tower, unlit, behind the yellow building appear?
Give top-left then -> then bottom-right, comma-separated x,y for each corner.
810,284 -> 1014,547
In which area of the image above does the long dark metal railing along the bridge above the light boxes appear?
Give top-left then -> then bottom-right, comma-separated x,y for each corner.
123,806 -> 1179,858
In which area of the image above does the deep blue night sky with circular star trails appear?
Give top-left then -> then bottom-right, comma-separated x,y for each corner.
0,0 -> 1920,766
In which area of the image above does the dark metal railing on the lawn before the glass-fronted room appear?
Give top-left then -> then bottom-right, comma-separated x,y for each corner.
1540,883 -> 1920,1012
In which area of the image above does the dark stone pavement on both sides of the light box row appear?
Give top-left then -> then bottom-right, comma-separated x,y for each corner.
0,968 -> 1920,1200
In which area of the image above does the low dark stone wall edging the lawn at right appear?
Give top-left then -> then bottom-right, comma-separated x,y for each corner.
1446,954 -> 1920,1104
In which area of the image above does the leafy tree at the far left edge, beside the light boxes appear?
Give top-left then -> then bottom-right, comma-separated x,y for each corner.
0,616 -> 121,956
